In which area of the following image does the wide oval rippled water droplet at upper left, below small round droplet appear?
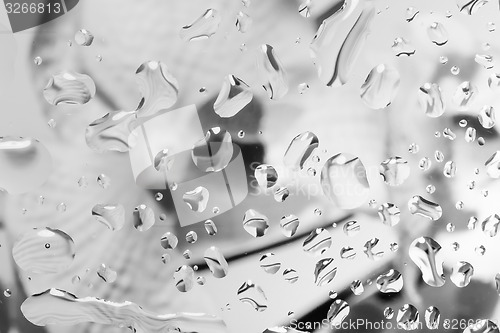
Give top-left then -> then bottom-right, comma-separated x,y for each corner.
43,71 -> 96,105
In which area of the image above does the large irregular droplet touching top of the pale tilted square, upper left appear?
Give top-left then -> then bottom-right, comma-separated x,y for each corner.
135,61 -> 179,117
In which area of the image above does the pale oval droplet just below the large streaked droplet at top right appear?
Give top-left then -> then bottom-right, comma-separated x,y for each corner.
360,64 -> 400,109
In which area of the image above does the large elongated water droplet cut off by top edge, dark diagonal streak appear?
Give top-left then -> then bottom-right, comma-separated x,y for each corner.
311,0 -> 375,87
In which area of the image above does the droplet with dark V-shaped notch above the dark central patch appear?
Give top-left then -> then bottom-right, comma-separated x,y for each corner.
214,75 -> 253,118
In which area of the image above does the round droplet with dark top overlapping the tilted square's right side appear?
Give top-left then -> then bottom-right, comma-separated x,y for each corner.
191,127 -> 233,172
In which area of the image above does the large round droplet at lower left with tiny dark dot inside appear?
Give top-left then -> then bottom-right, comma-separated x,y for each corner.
12,227 -> 75,274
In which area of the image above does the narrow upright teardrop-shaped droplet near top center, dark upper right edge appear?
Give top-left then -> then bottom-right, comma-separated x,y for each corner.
259,44 -> 288,99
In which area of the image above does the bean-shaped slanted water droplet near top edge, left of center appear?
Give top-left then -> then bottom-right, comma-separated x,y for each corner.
179,9 -> 222,42
